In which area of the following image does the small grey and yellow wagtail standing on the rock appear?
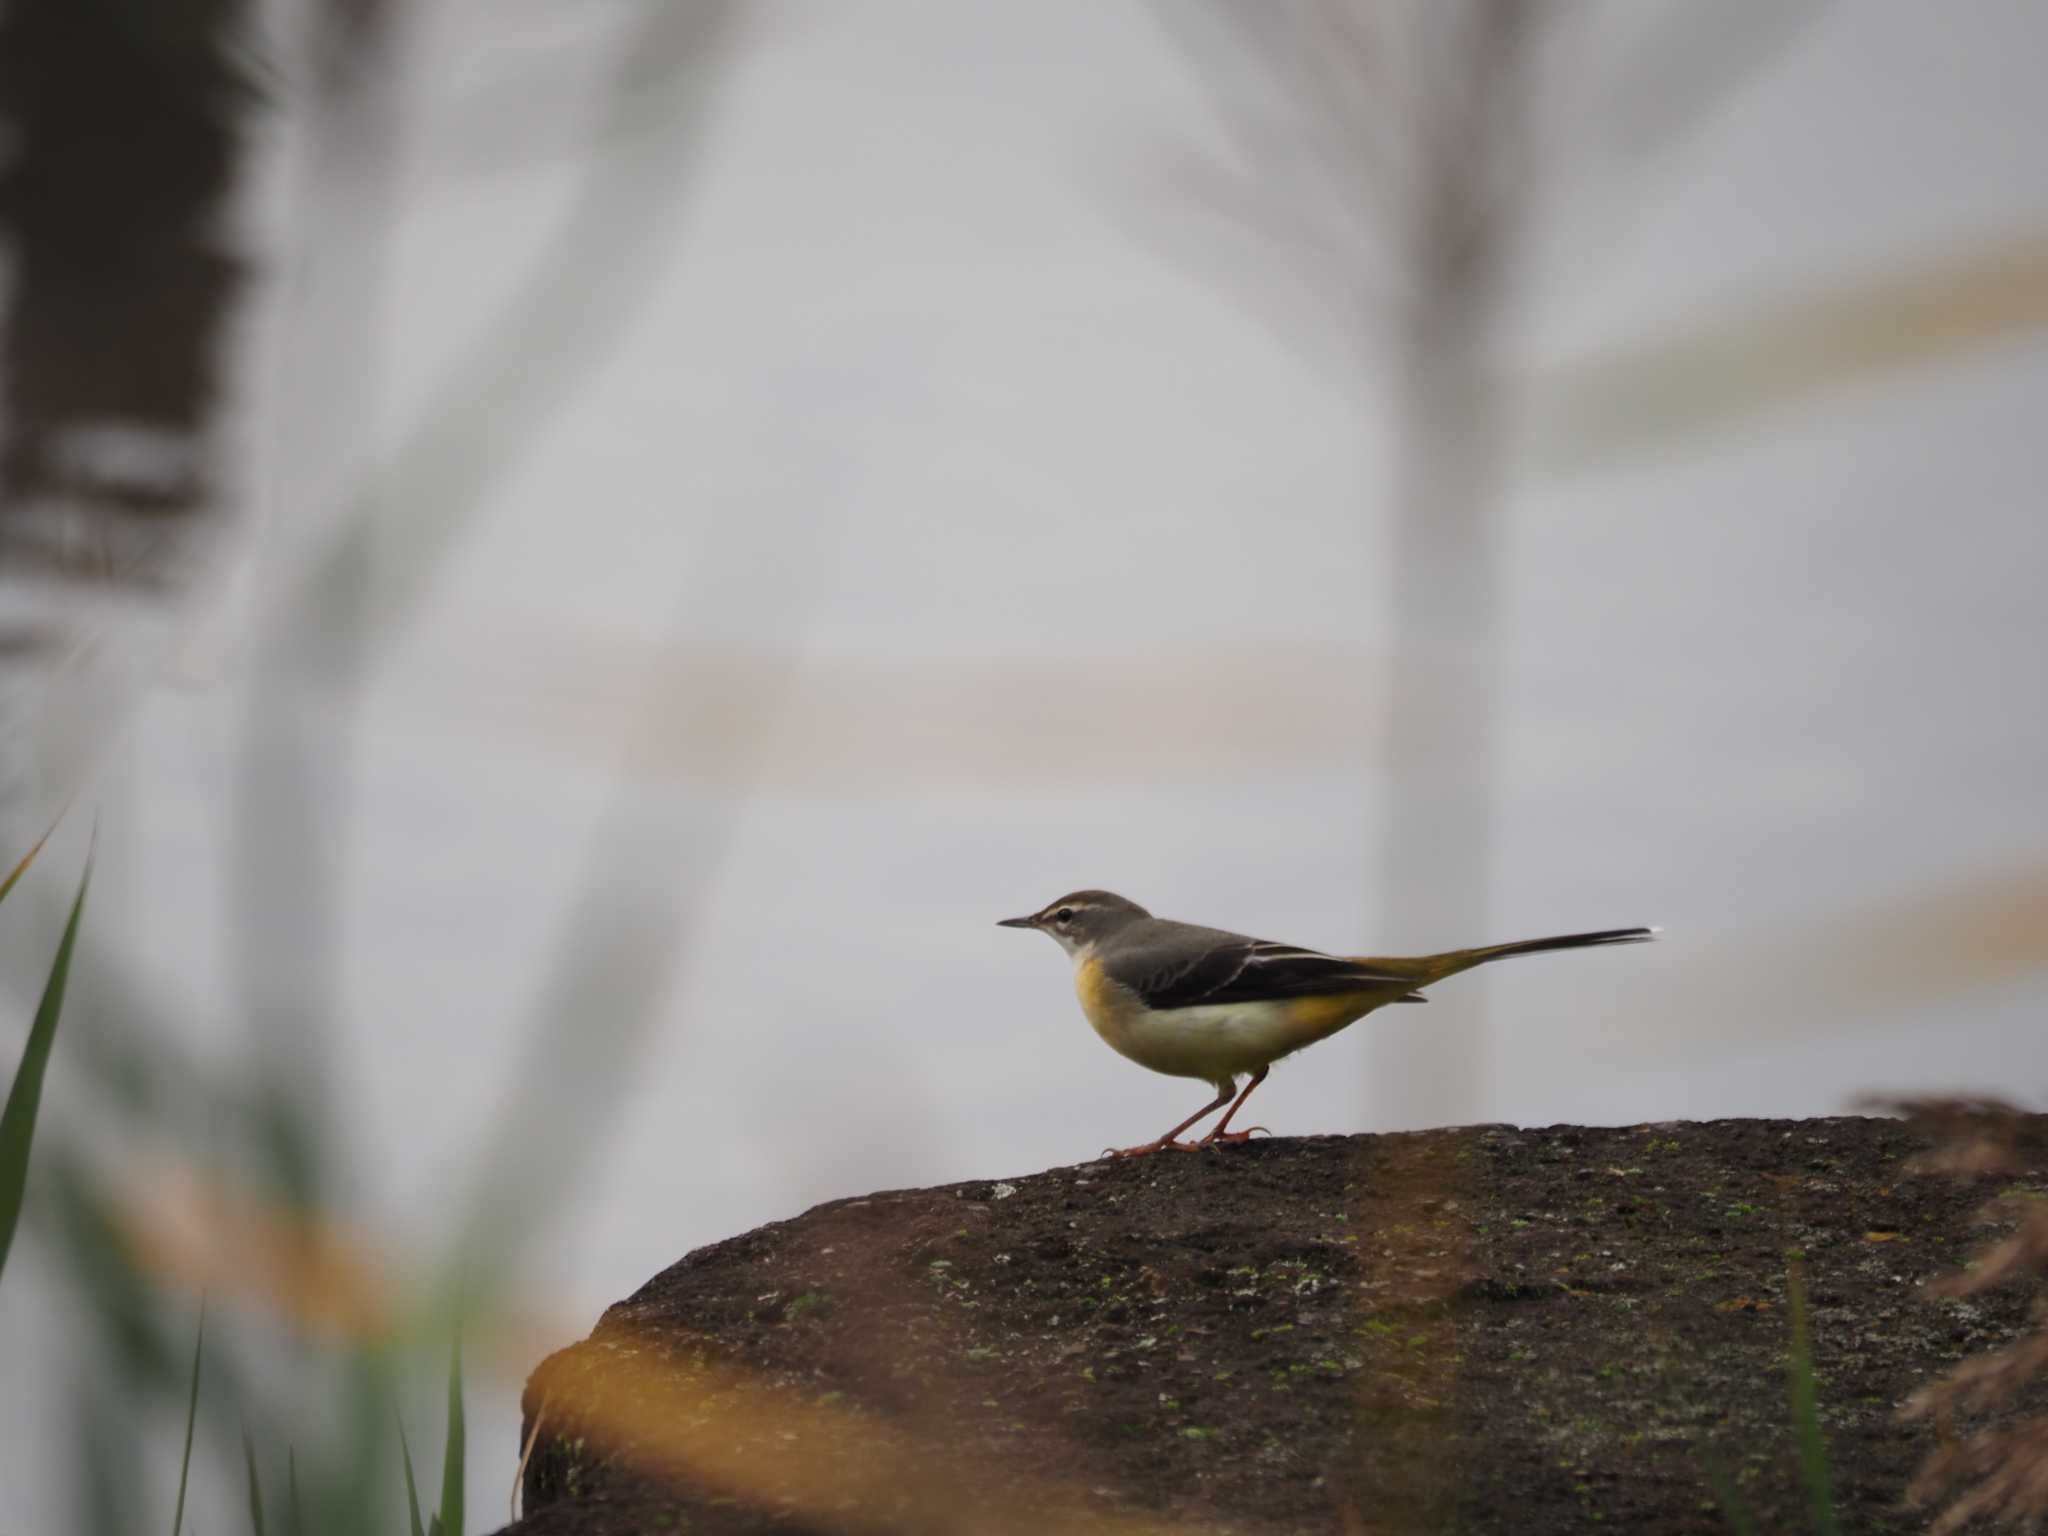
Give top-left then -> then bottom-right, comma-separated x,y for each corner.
997,891 -> 1657,1157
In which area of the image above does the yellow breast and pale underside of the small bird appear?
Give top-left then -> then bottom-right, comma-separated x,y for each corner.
1075,965 -> 1395,1083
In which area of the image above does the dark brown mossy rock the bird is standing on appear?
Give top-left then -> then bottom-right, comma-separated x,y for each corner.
510,1118 -> 2048,1536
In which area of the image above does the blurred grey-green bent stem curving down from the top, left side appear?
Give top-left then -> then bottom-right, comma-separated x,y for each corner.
238,0 -> 737,1190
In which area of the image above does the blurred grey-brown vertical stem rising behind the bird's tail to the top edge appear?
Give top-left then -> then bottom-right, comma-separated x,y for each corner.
1378,0 -> 1552,1097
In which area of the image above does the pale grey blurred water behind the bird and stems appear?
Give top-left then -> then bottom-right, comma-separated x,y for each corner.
0,0 -> 2048,1532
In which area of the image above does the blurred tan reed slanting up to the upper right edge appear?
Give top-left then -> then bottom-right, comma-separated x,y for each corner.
1534,233 -> 2048,473
